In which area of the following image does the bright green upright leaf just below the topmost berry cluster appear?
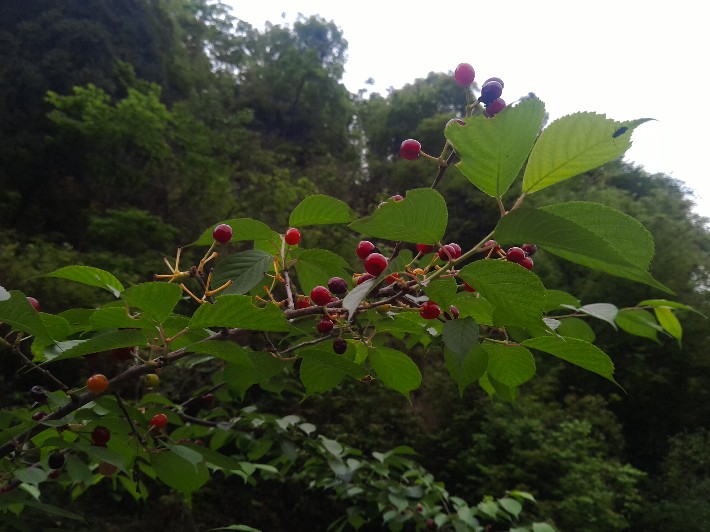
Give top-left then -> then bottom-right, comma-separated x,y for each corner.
445,97 -> 545,197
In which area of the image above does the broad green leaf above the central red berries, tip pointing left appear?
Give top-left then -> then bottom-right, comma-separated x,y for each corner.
349,188 -> 448,244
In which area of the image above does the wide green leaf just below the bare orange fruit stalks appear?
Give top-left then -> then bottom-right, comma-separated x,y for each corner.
190,295 -> 289,332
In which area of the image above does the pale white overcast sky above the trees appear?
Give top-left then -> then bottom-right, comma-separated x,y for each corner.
224,0 -> 710,218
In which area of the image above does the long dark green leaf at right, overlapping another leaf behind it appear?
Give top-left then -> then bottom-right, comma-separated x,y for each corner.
495,205 -> 672,293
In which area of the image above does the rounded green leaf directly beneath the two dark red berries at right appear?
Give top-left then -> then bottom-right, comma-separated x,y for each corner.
459,260 -> 545,327
